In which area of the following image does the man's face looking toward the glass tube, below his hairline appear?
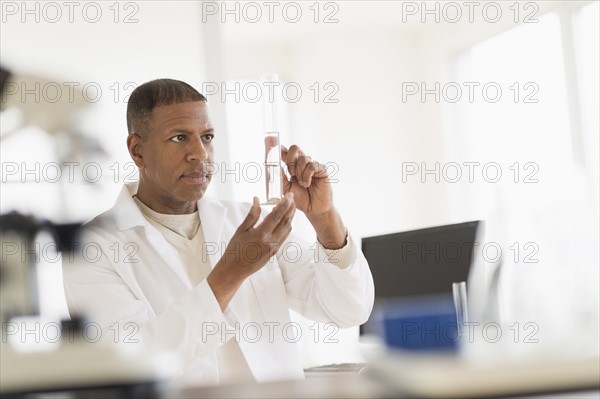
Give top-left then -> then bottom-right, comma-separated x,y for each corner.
128,101 -> 214,213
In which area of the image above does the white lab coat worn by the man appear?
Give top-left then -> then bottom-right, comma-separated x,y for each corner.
63,184 -> 374,384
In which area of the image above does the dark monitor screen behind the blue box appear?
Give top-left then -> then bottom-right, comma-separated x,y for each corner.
362,221 -> 479,298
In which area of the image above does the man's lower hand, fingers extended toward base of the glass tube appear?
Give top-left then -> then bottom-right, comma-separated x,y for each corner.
206,193 -> 296,310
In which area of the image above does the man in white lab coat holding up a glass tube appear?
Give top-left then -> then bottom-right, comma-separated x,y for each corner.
64,79 -> 374,384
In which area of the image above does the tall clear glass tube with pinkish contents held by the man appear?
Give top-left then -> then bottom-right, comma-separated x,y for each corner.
261,74 -> 283,204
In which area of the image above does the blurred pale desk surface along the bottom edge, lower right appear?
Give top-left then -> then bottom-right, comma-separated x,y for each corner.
167,357 -> 600,399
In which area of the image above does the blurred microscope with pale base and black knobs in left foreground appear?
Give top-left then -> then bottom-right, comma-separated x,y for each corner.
0,67 -> 175,398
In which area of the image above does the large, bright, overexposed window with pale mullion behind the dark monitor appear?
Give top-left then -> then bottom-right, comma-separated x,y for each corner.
449,2 -> 600,340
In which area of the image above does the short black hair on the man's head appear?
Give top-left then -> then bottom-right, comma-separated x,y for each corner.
127,79 -> 206,136
